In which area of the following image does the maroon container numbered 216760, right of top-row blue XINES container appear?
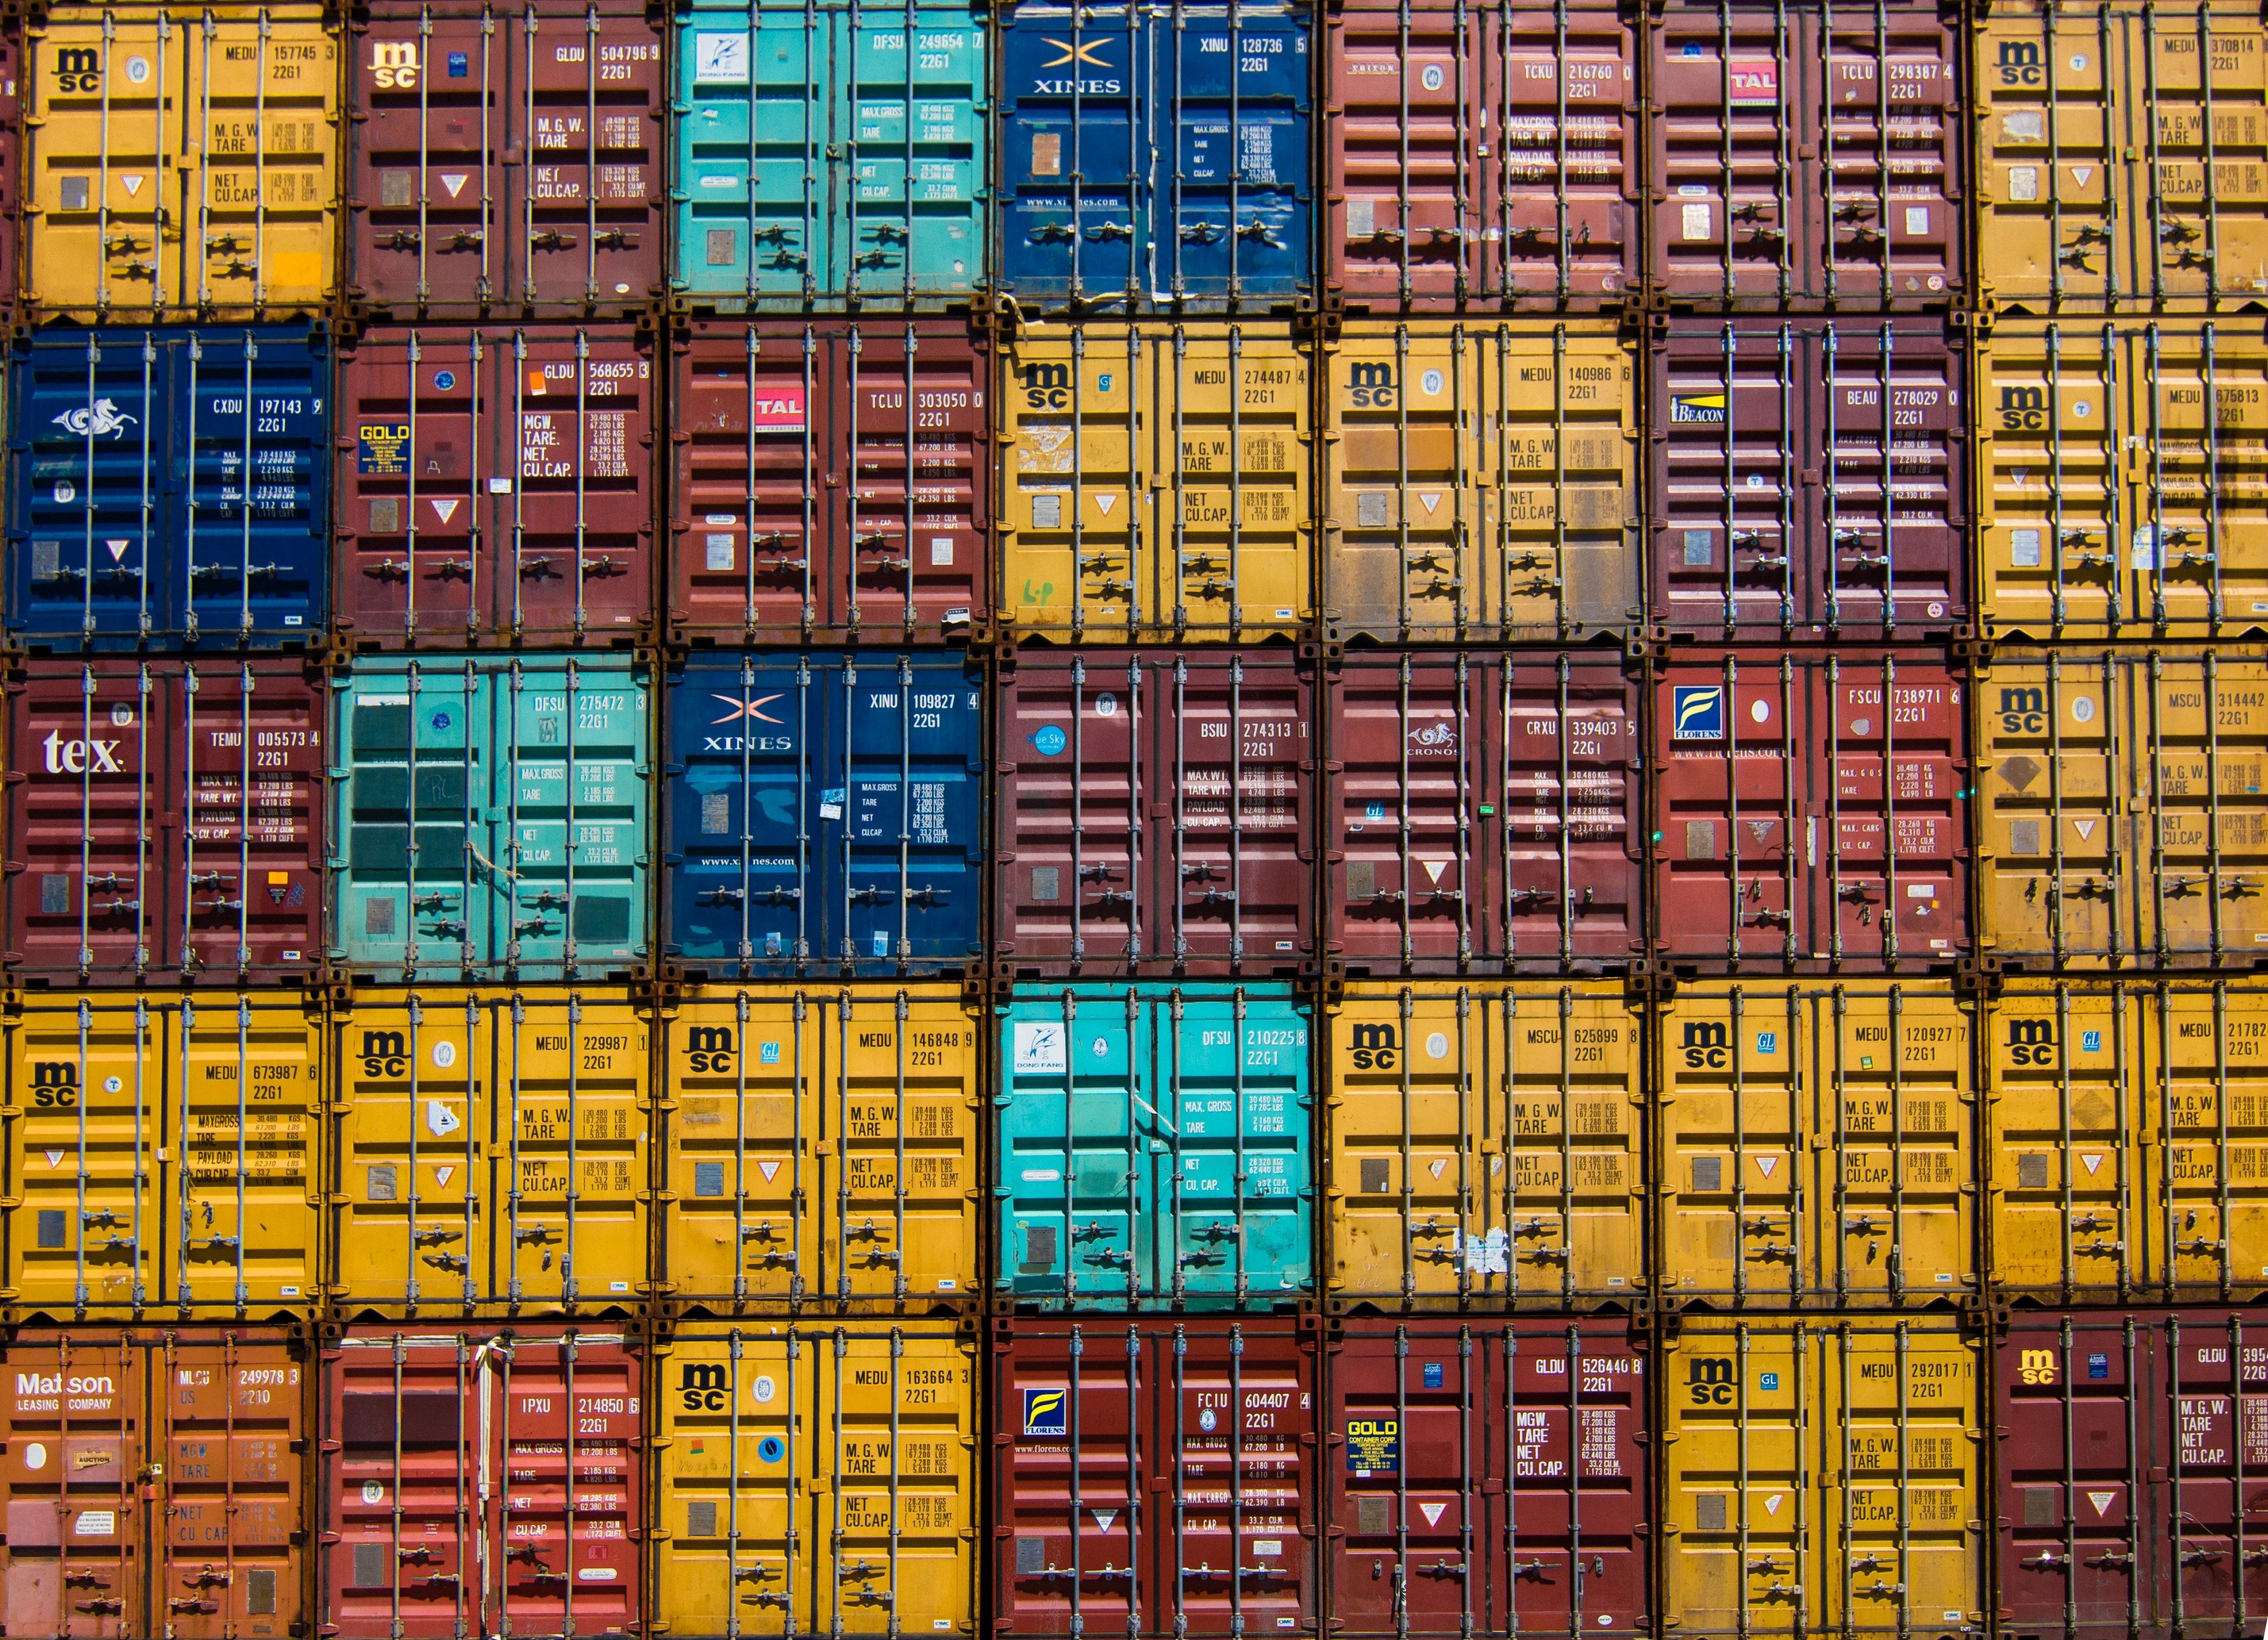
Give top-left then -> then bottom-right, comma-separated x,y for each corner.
1325,0 -> 1640,313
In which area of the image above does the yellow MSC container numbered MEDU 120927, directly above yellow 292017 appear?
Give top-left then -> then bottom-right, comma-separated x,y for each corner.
1653,980 -> 1982,1313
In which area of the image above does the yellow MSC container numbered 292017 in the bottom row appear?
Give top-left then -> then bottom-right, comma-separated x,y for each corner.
1656,1316 -> 1989,1640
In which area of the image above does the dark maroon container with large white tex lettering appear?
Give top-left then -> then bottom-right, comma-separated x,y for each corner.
5,656 -> 329,984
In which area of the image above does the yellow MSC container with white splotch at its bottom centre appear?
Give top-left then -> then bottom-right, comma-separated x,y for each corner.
1322,980 -> 1649,1309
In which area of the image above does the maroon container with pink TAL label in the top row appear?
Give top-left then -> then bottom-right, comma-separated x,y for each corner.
1647,0 -> 1969,311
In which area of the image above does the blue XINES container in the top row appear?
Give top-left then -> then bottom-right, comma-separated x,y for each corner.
998,5 -> 1315,311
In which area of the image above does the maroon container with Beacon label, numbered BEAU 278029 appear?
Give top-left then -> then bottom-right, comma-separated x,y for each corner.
1649,318 -> 1971,642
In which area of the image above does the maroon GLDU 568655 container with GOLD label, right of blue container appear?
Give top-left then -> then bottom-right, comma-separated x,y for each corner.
331,324 -> 660,649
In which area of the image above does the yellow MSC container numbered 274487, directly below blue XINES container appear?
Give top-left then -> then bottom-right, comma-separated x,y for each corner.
993,322 -> 1315,644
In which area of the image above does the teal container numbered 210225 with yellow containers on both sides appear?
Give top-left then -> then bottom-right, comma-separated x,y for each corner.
996,984 -> 1315,1309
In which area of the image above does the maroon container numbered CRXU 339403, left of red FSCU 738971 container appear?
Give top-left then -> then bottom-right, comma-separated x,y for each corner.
1322,651 -> 1644,976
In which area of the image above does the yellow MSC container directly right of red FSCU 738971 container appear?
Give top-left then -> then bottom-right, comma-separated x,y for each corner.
1976,647 -> 2268,973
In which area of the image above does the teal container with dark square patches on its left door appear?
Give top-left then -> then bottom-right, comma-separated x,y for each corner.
331,653 -> 653,982
